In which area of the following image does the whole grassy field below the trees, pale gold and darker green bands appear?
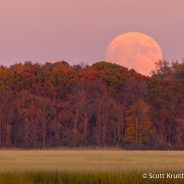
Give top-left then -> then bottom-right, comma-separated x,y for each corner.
0,150 -> 184,184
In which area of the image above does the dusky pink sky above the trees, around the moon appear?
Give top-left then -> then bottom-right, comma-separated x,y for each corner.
0,0 -> 184,66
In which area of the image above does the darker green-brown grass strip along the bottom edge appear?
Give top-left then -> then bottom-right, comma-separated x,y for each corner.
0,172 -> 183,184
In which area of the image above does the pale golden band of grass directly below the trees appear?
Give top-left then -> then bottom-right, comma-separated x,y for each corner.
0,150 -> 184,173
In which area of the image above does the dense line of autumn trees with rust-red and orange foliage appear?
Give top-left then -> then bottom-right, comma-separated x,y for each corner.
0,61 -> 184,149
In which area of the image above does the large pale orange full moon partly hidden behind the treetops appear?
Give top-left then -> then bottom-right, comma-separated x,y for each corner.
106,32 -> 162,75
